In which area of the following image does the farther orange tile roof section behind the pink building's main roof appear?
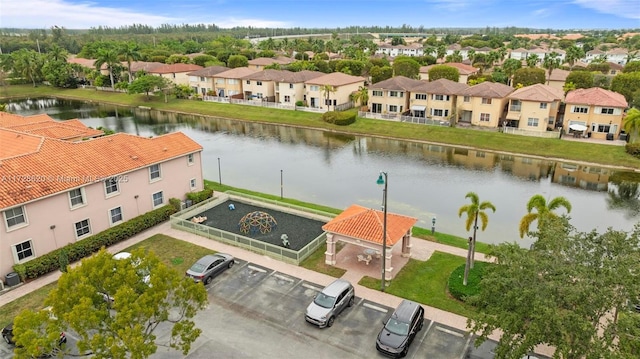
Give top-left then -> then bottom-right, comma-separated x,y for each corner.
0,112 -> 104,140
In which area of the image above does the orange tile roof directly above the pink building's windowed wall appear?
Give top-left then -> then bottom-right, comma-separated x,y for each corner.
0,129 -> 202,209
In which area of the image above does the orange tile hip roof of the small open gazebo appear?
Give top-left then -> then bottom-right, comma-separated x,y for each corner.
322,205 -> 418,247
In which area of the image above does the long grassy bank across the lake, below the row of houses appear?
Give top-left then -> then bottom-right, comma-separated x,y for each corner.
0,85 -> 640,171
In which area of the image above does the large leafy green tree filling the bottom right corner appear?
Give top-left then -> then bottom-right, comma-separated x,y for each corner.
467,217 -> 640,359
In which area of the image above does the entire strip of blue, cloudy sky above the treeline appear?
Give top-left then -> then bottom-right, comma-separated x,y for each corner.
0,0 -> 640,29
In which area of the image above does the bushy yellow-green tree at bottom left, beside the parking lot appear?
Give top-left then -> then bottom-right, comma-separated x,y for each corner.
14,249 -> 208,359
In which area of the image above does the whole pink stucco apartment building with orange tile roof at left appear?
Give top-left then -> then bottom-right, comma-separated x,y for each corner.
0,112 -> 203,278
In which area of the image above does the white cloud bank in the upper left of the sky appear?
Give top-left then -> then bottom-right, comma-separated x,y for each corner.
0,0 -> 180,29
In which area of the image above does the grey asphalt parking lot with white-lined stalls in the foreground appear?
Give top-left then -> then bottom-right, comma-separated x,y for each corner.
0,259 -> 504,359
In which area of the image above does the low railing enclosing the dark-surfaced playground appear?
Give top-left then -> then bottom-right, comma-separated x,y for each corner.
170,191 -> 335,265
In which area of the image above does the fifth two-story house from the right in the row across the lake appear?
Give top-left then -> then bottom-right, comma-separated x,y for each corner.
368,76 -> 424,117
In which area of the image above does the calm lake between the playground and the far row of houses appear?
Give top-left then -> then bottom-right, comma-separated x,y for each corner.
8,99 -> 640,247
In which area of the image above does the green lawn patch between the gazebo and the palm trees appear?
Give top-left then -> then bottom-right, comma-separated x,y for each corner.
359,252 -> 474,317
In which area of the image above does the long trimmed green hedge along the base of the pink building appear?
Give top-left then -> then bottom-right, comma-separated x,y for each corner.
13,205 -> 176,280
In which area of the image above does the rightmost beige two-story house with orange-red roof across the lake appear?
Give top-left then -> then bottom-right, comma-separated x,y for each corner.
562,87 -> 629,140
